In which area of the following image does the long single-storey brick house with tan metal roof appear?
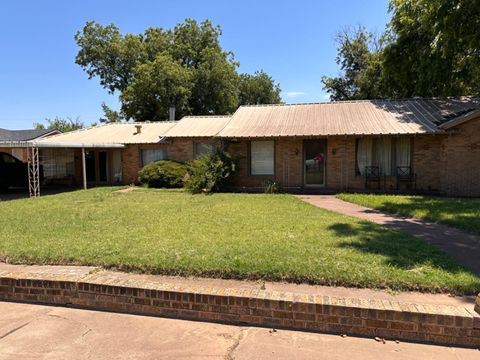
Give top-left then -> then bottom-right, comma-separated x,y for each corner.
29,97 -> 480,196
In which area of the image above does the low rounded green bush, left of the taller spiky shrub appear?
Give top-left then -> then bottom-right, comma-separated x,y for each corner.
138,160 -> 187,188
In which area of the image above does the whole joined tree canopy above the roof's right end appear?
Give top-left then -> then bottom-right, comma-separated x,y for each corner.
322,0 -> 480,100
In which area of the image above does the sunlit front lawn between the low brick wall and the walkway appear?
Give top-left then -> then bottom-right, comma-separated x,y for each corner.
0,188 -> 480,294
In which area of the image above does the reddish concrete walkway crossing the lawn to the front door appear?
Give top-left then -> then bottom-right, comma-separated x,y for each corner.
297,195 -> 480,275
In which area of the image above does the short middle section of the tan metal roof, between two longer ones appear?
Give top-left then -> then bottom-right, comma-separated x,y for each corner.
165,115 -> 230,137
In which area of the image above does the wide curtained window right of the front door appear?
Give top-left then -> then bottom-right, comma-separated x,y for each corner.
356,137 -> 411,176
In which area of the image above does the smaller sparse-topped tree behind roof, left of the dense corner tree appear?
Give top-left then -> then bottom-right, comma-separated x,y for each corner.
322,26 -> 384,101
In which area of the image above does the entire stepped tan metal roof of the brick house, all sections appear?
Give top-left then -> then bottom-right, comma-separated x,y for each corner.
16,97 -> 480,147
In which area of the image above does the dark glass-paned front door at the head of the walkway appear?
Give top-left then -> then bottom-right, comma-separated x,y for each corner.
303,139 -> 327,186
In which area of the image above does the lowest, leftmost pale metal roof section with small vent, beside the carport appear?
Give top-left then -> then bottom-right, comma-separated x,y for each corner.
36,121 -> 176,146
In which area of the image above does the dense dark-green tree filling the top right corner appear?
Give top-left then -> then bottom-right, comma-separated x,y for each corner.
383,0 -> 480,97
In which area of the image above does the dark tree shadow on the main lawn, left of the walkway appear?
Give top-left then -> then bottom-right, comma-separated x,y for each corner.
328,222 -> 474,273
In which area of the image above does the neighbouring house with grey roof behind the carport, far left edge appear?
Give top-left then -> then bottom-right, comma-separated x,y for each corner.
0,128 -> 61,161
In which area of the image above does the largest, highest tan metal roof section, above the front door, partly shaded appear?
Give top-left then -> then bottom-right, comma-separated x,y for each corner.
218,97 -> 480,137
